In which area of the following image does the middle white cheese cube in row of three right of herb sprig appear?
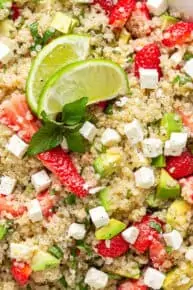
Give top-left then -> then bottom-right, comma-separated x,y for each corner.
142,138 -> 163,158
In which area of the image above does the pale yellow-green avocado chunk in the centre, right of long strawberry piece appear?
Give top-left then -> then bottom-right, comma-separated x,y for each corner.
93,152 -> 121,177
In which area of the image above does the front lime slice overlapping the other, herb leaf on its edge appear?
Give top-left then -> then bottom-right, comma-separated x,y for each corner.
38,60 -> 128,115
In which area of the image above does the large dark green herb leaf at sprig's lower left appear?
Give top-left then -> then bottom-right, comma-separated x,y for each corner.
27,123 -> 63,156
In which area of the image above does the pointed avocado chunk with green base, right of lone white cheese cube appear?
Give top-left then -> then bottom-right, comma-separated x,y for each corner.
156,169 -> 180,199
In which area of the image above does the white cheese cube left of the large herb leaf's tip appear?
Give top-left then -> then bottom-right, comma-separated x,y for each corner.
6,135 -> 28,159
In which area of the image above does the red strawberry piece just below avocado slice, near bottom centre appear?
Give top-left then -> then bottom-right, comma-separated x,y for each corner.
96,235 -> 129,258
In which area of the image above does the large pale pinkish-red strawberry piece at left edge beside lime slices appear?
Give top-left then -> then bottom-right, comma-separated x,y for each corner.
0,94 -> 39,143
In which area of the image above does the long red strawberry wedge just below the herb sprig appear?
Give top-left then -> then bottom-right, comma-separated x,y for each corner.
38,147 -> 88,197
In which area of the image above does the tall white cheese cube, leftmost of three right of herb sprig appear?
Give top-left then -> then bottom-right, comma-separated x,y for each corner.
125,120 -> 143,145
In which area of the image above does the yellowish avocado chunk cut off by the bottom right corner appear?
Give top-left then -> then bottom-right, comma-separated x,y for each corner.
163,263 -> 193,290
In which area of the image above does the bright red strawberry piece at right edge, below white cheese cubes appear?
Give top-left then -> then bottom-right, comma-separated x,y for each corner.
166,151 -> 193,179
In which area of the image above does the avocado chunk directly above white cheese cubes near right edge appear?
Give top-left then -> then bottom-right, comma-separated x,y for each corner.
160,113 -> 183,140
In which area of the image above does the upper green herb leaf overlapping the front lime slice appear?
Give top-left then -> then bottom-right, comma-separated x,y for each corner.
62,97 -> 88,126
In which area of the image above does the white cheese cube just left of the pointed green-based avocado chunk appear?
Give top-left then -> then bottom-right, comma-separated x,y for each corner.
134,167 -> 155,188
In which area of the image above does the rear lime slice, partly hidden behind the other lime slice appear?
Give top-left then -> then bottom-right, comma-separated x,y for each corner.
27,35 -> 90,113
